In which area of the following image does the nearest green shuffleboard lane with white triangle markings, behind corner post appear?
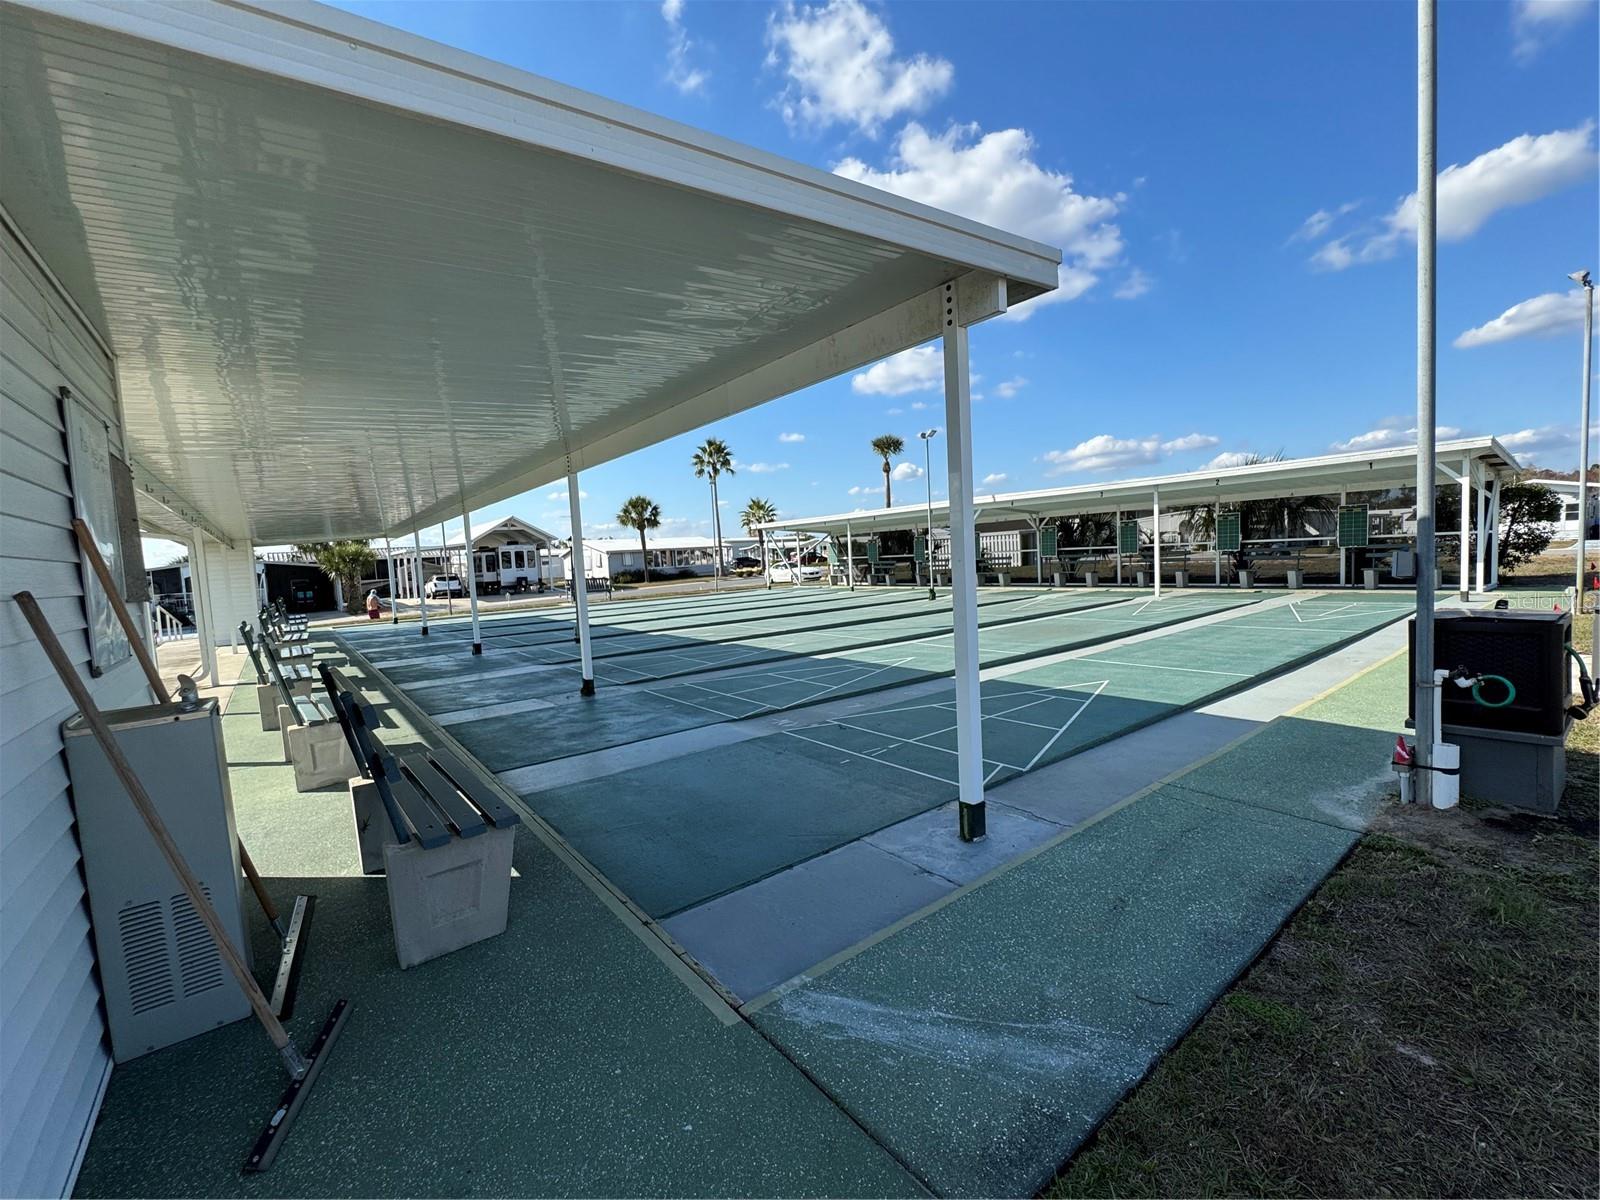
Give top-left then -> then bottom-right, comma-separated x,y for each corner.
518,600 -> 1410,918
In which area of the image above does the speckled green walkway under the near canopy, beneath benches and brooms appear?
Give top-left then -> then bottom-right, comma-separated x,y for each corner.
77,668 -> 917,1197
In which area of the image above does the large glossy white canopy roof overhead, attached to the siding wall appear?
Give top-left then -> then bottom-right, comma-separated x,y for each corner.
0,0 -> 1059,542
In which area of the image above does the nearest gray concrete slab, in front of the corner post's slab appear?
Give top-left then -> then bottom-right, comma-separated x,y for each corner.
661,842 -> 955,1000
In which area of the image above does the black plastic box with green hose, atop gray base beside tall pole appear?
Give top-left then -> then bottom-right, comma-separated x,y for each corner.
1410,608 -> 1573,738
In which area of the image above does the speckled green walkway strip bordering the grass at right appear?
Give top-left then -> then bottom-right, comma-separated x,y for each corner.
754,659 -> 1405,1195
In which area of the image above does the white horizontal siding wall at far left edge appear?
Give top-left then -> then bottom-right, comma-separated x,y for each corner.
0,229 -> 149,1195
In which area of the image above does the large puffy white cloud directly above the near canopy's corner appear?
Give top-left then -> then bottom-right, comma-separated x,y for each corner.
834,122 -> 1125,320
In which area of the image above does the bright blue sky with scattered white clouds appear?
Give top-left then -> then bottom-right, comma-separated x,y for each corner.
150,0 -> 1600,563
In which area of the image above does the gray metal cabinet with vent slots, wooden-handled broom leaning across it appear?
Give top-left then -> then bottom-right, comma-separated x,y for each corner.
62,699 -> 250,1062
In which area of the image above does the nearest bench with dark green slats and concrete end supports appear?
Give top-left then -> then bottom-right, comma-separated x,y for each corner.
318,662 -> 520,968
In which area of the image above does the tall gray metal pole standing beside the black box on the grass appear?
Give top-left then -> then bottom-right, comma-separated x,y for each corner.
1411,0 -> 1438,808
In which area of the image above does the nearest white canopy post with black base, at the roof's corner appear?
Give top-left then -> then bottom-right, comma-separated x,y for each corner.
942,283 -> 986,842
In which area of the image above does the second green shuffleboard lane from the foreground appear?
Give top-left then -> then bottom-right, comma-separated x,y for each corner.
425,592 -> 1259,771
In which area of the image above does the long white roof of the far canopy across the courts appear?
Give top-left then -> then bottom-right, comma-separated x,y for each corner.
774,437 -> 1517,533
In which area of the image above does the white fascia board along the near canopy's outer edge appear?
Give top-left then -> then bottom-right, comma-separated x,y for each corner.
14,0 -> 1061,291
